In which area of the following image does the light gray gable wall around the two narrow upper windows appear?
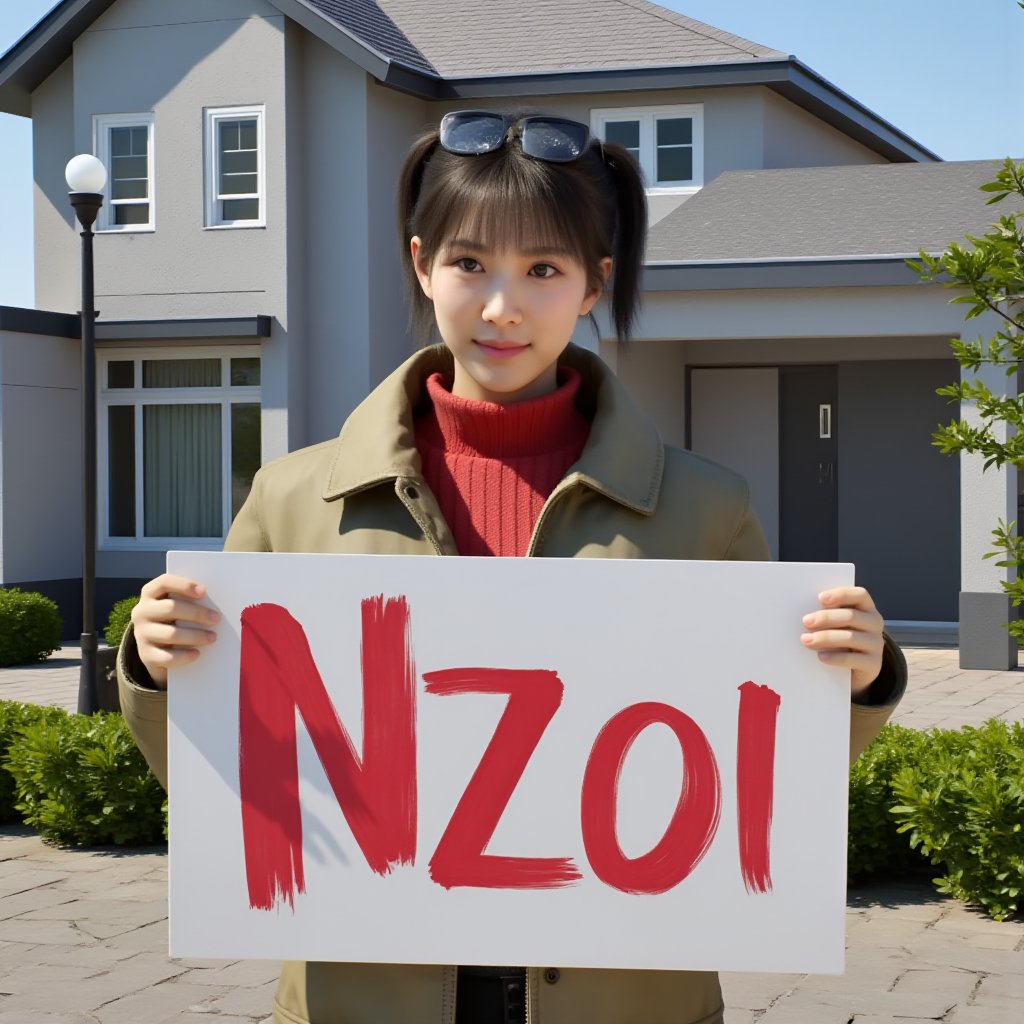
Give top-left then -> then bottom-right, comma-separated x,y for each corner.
34,0 -> 296,460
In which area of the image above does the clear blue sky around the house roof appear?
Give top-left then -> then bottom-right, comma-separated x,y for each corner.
0,0 -> 1024,306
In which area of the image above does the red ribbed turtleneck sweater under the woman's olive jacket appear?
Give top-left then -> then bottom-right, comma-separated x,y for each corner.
416,368 -> 590,555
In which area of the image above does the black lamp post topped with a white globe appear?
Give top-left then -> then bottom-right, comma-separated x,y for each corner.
65,154 -> 106,715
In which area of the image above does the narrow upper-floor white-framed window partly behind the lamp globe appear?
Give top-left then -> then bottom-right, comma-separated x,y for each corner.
92,114 -> 157,231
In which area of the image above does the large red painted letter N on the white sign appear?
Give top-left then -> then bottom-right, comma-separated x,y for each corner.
239,597 -> 416,910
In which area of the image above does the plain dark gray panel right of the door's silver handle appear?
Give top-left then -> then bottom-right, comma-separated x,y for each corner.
838,358 -> 961,622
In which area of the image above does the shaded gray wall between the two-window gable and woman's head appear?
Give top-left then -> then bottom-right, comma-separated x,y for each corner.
289,33 -> 429,443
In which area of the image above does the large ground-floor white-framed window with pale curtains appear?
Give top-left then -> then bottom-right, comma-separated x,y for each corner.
97,345 -> 260,550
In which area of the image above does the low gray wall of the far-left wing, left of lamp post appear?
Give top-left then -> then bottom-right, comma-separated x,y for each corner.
0,332 -> 82,585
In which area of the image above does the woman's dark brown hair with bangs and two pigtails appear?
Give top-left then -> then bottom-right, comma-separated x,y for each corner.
398,113 -> 647,341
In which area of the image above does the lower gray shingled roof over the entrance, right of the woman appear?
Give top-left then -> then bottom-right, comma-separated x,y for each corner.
647,160 -> 1016,263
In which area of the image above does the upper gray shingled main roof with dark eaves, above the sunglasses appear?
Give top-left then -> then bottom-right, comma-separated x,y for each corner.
0,0 -> 939,161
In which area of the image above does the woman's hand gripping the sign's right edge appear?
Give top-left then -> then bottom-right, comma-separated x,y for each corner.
800,587 -> 885,697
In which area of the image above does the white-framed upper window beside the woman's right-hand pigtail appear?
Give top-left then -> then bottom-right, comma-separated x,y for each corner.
591,103 -> 703,194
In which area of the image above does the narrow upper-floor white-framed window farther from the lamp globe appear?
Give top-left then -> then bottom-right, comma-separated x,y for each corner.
204,106 -> 266,227
